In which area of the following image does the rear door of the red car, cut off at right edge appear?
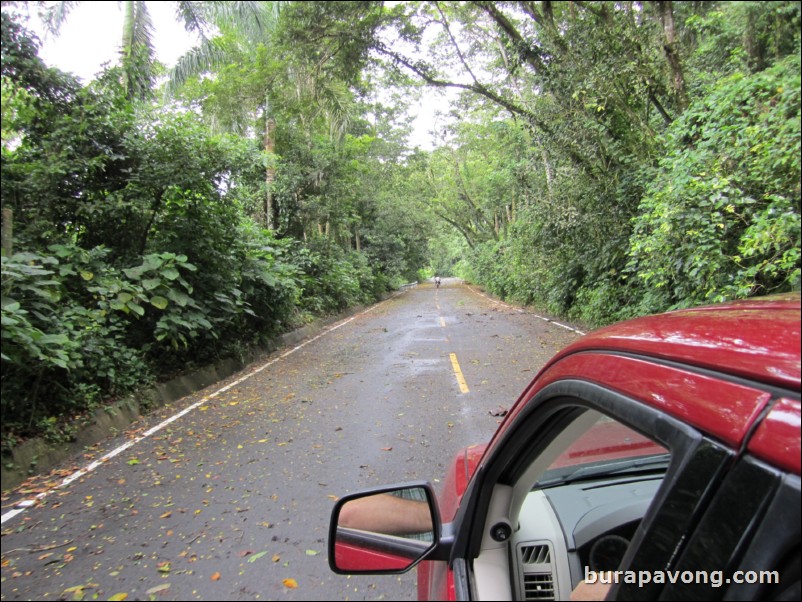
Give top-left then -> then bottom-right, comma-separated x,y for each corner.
663,396 -> 802,600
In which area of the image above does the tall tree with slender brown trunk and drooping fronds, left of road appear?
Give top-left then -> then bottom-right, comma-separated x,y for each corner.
168,2 -> 378,229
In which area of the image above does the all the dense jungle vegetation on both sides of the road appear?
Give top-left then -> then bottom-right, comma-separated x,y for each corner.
2,1 -> 800,447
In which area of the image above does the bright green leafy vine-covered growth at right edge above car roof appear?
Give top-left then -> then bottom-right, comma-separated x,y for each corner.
629,56 -> 800,310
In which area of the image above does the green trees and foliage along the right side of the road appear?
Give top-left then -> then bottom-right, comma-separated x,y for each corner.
378,2 -> 800,325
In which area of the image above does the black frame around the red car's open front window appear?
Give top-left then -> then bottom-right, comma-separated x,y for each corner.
444,354 -> 764,599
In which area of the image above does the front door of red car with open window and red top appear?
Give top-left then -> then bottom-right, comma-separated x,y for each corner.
444,353 -> 766,600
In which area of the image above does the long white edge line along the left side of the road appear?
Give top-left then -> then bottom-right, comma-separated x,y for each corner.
0,291 -> 396,524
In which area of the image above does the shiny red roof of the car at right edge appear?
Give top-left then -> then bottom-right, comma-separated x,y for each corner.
554,293 -> 802,393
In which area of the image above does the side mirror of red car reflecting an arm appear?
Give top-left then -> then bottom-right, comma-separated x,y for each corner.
329,483 -> 440,574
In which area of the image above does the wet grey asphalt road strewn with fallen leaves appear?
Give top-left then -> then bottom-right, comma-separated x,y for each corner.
2,280 -> 578,600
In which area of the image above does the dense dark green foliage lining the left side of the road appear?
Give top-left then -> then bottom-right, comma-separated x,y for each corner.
2,11 -> 412,442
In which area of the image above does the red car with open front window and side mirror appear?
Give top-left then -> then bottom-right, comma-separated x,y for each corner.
329,294 -> 802,600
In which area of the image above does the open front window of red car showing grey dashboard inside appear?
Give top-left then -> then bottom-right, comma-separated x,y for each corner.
510,412 -> 671,600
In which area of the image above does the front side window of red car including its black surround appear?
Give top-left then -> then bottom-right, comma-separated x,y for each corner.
452,372 -> 737,600
